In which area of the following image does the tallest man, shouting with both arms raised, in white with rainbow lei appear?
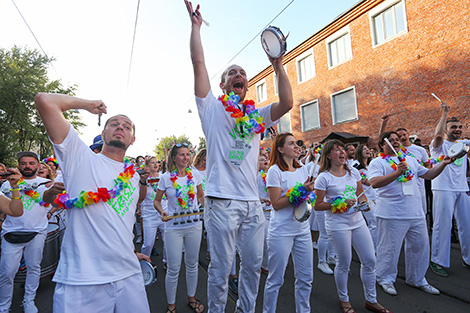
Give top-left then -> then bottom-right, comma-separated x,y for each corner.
185,1 -> 293,313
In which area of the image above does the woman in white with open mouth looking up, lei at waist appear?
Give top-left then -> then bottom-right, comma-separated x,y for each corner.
315,140 -> 390,313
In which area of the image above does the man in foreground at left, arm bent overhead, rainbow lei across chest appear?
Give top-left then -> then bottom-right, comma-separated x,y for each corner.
36,93 -> 150,312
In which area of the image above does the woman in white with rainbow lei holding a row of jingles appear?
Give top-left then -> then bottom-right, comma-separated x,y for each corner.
154,143 -> 204,313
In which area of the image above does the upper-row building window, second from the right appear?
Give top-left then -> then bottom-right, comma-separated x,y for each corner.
326,26 -> 352,68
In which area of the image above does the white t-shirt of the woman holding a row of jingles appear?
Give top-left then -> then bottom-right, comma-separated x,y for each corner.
158,171 -> 202,229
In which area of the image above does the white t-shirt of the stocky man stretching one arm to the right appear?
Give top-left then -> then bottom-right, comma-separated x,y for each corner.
369,156 -> 428,219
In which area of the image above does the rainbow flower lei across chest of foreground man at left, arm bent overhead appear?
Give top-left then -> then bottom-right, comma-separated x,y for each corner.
54,158 -> 135,209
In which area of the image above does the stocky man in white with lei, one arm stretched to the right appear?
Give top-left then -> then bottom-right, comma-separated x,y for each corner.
369,131 -> 453,295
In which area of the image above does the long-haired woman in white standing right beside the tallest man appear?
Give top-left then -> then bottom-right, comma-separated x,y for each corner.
263,133 -> 314,313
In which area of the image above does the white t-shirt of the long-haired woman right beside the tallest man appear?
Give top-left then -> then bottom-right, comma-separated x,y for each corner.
266,165 -> 310,236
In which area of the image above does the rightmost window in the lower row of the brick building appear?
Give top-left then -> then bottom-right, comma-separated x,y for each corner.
331,87 -> 357,125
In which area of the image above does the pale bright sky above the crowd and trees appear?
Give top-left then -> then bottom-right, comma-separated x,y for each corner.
0,0 -> 360,156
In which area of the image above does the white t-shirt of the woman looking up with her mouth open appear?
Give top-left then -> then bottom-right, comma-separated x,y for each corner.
315,168 -> 364,230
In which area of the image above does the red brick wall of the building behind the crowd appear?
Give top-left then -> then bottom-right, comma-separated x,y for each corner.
248,0 -> 470,148
